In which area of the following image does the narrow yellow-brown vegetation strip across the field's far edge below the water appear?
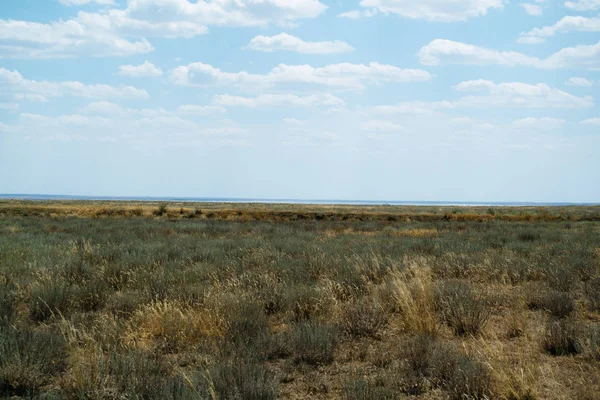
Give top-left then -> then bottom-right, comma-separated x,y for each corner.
0,201 -> 600,222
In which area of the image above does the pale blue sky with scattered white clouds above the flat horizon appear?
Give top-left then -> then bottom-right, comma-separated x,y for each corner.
0,0 -> 600,203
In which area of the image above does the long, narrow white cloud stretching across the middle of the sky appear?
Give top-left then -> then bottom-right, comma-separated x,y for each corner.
170,63 -> 432,90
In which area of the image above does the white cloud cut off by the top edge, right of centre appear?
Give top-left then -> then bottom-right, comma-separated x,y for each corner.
360,0 -> 504,22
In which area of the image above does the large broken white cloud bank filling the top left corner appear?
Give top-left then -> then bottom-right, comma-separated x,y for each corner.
0,0 -> 327,58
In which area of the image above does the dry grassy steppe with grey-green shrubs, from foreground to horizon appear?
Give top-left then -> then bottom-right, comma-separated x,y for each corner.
0,201 -> 600,400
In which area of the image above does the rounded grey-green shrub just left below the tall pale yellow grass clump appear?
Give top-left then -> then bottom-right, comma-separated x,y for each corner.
343,298 -> 387,338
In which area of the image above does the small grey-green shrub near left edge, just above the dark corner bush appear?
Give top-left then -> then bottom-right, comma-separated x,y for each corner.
29,281 -> 72,322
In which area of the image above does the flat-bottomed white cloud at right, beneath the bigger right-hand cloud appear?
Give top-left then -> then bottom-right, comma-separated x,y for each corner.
453,79 -> 594,109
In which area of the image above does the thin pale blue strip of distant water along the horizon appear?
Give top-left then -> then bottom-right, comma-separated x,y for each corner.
0,194 -> 597,207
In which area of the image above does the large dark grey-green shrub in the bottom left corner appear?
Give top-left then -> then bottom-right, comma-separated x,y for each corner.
0,326 -> 67,397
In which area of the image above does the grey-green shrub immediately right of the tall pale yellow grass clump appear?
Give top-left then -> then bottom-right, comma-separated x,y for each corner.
437,280 -> 492,335
